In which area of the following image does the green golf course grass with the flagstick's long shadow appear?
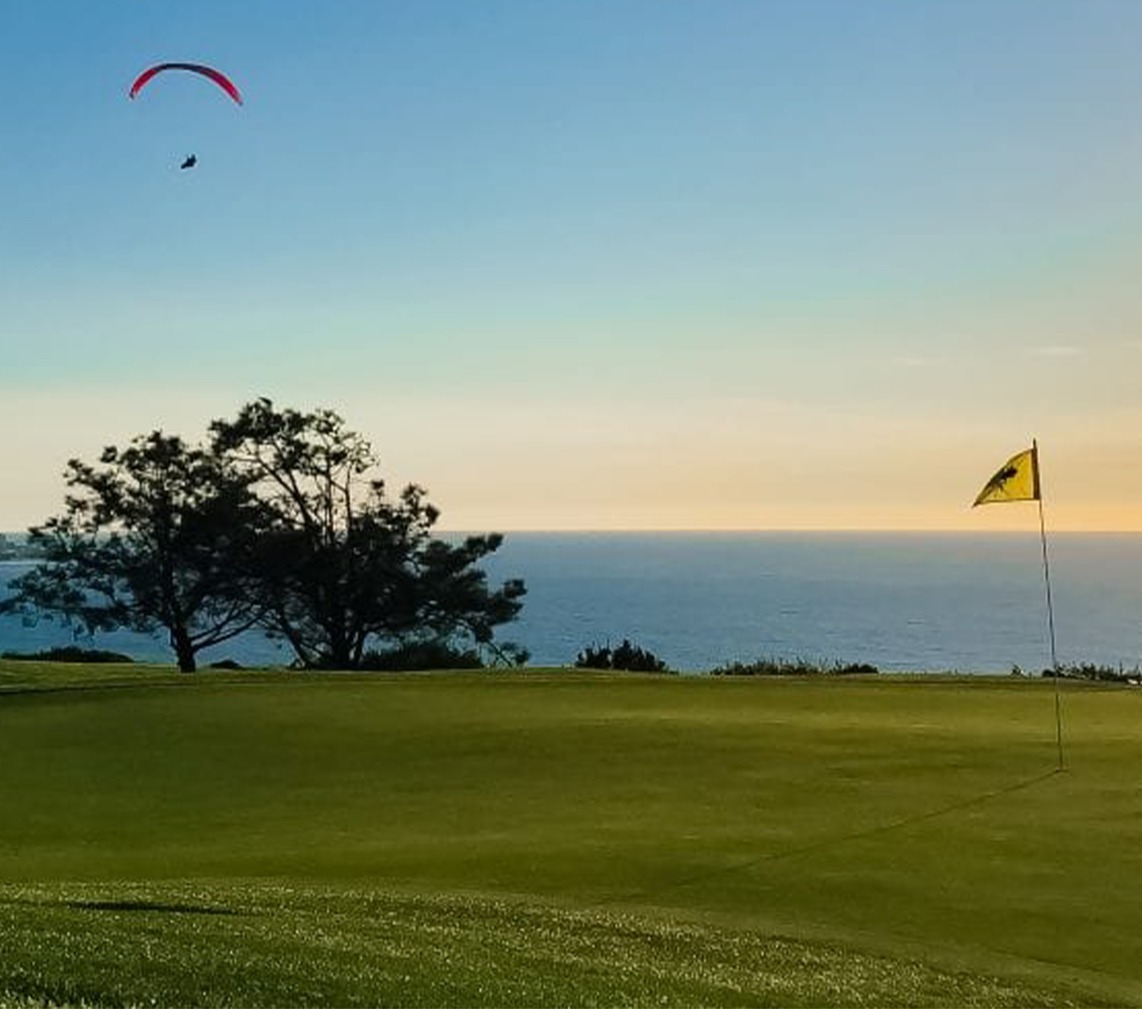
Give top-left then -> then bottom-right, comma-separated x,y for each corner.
0,662 -> 1142,1007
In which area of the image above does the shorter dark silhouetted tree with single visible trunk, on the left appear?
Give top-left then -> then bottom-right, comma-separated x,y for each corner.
2,431 -> 260,672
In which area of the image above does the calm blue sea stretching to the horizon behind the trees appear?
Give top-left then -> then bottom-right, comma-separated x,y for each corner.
0,533 -> 1142,672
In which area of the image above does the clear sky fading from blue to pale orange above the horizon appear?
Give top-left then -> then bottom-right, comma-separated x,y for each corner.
0,0 -> 1142,532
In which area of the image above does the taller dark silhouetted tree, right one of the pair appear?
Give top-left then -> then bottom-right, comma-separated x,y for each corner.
210,399 -> 526,669
